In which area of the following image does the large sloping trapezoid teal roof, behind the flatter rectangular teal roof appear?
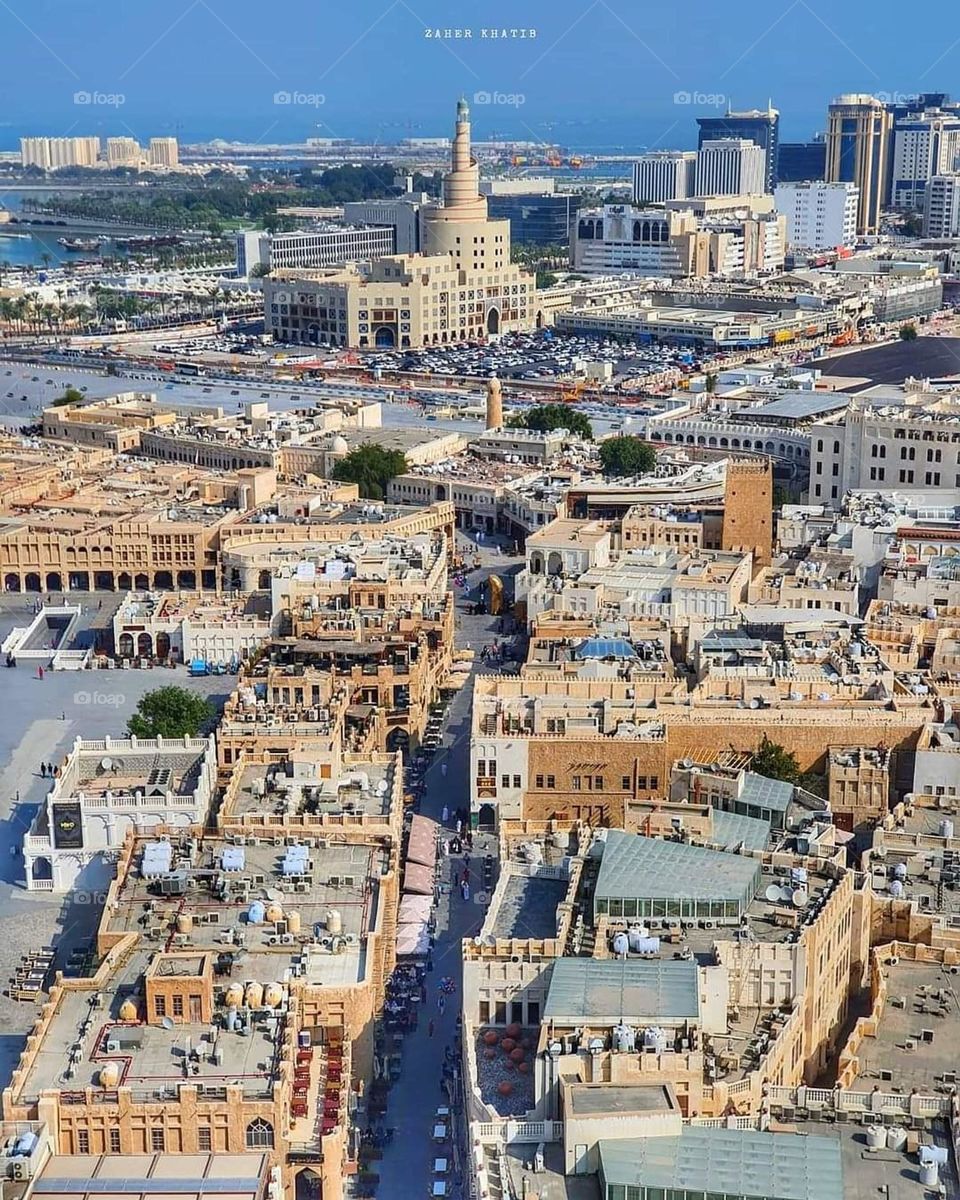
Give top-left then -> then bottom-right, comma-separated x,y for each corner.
594,829 -> 761,904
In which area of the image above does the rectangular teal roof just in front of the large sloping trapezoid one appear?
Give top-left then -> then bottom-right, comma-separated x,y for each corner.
544,959 -> 700,1026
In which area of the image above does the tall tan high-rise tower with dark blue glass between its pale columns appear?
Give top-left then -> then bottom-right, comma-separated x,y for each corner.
826,92 -> 893,234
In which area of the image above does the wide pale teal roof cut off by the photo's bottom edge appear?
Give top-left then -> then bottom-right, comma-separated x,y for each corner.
598,1126 -> 844,1200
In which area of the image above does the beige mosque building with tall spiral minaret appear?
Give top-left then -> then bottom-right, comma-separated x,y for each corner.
264,100 -> 544,349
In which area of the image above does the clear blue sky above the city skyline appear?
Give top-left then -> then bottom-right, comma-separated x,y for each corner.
0,0 -> 960,149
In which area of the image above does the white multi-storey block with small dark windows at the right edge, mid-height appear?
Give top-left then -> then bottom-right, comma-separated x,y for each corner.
810,394 -> 960,509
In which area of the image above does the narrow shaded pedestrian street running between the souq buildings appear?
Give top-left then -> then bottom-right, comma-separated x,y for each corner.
364,535 -> 518,1200
